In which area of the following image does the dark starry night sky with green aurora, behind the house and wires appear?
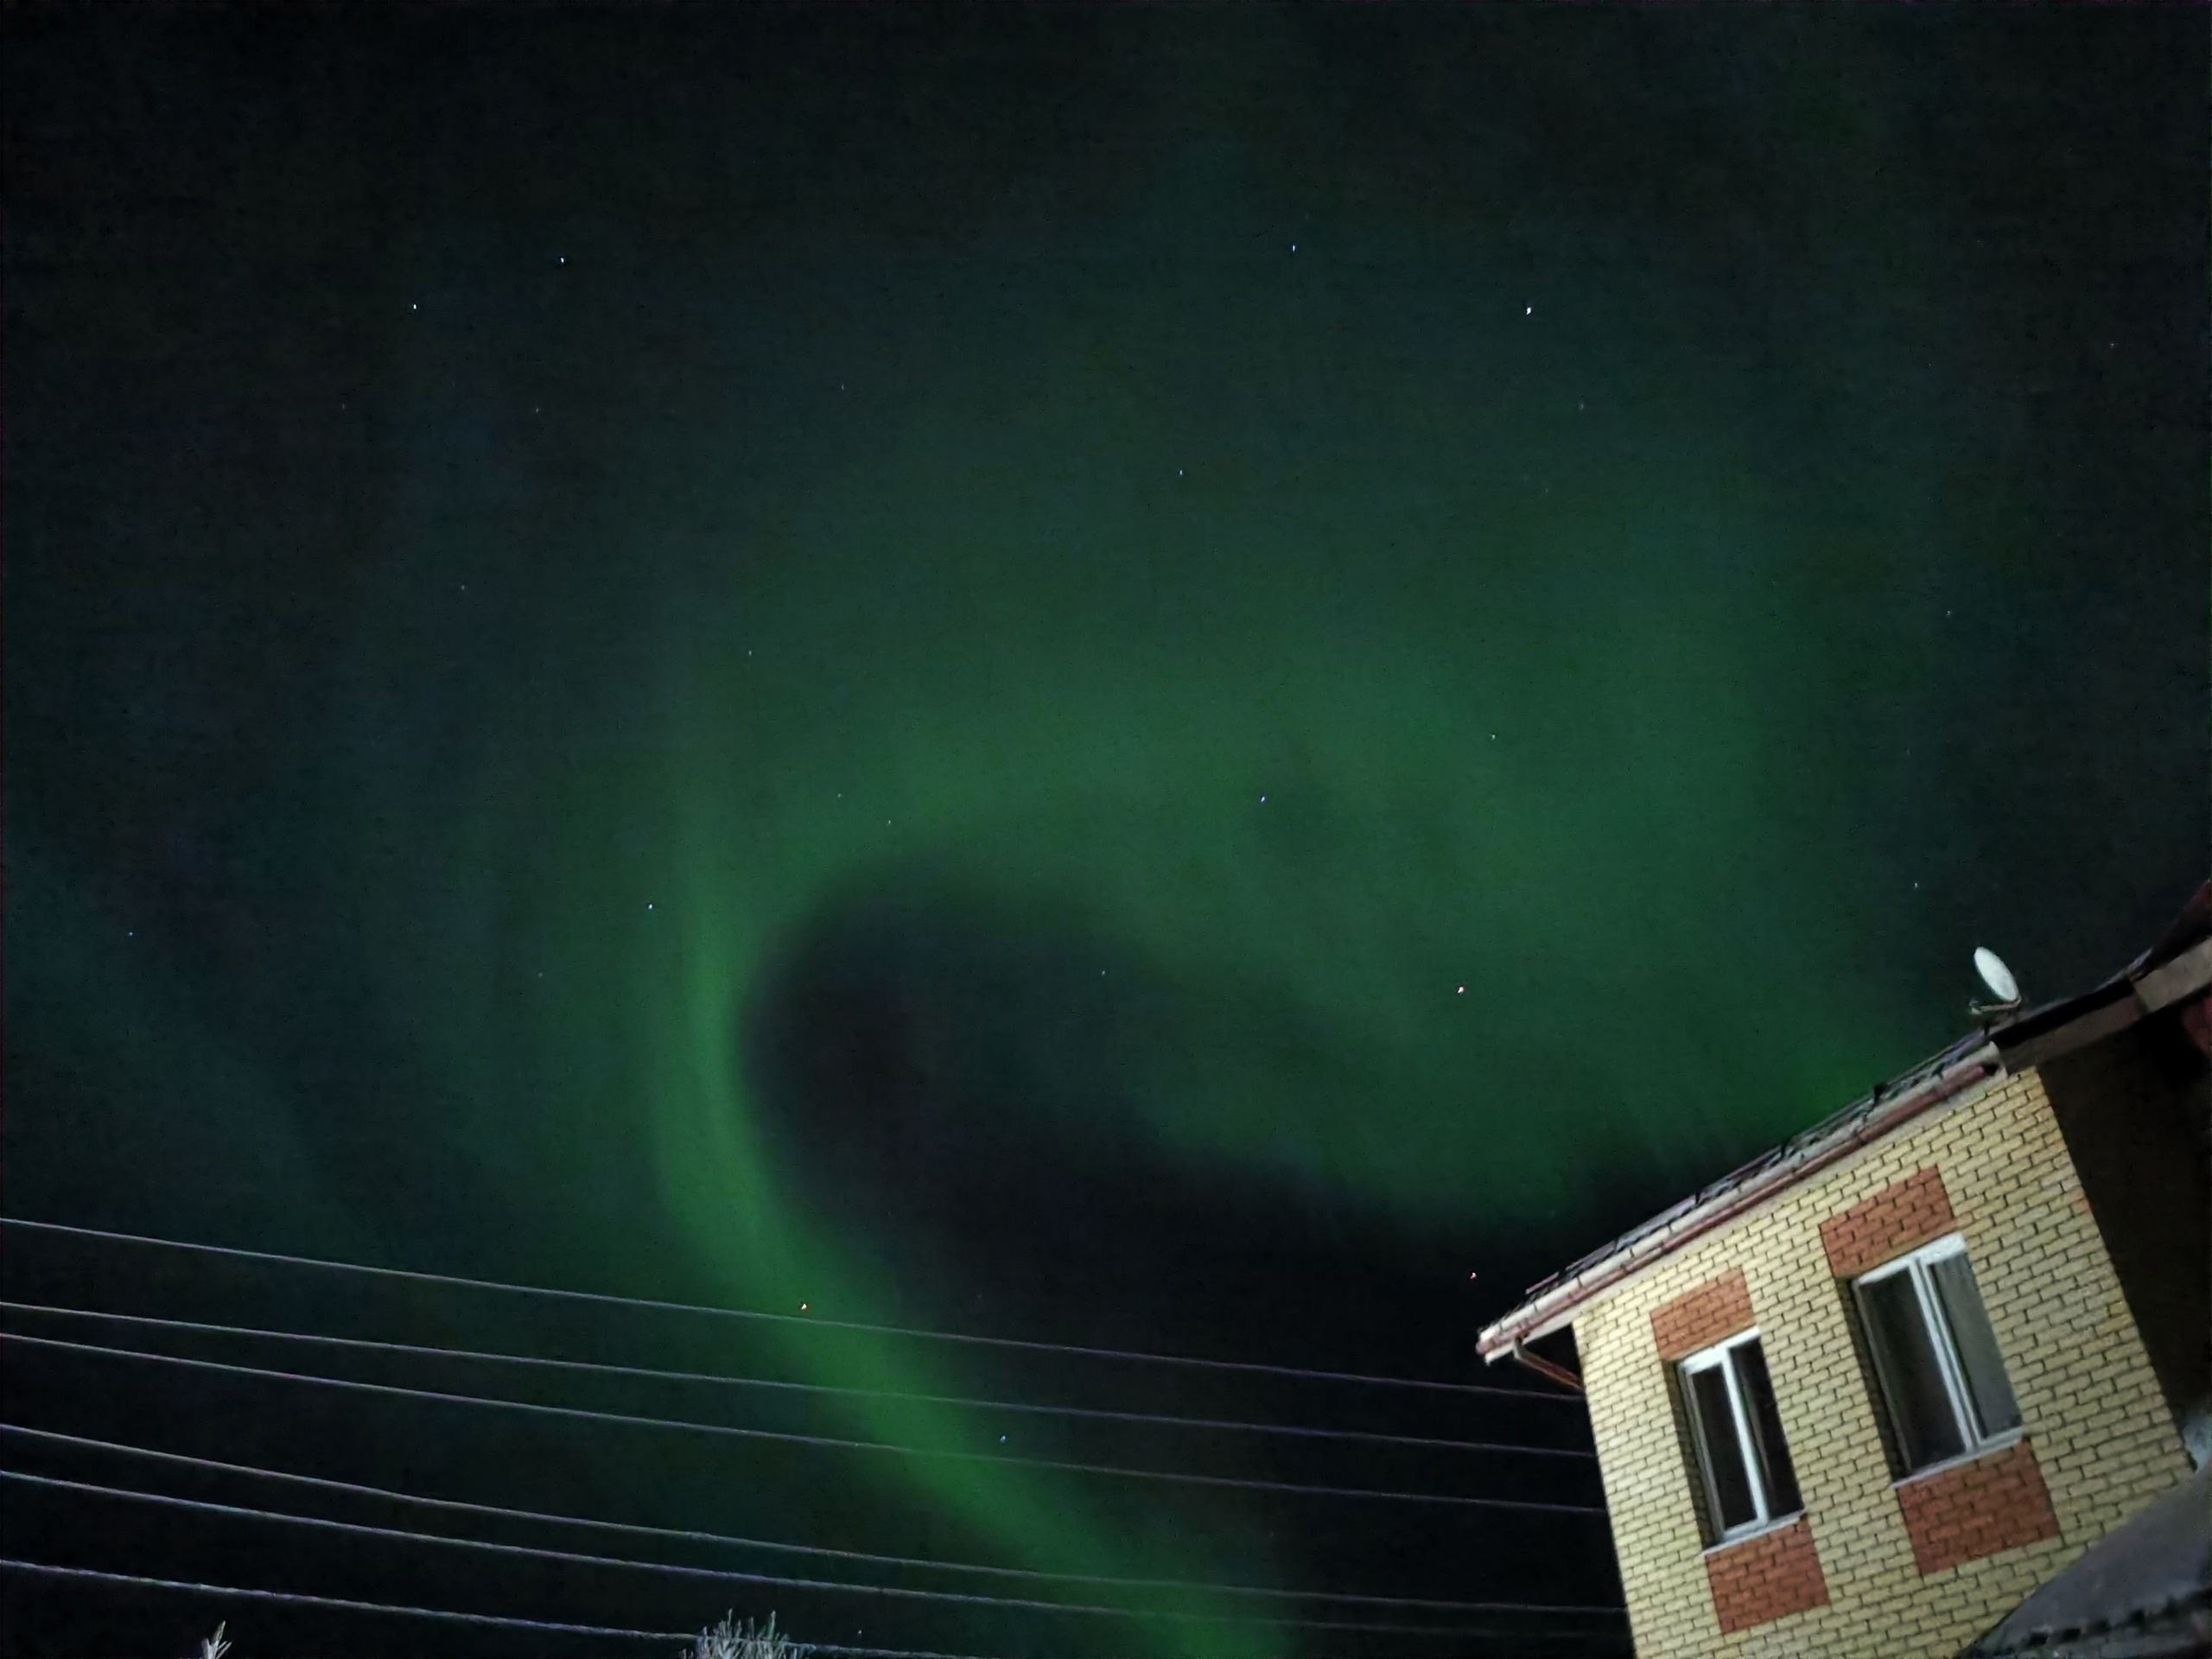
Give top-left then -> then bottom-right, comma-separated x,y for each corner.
0,7 -> 2212,1659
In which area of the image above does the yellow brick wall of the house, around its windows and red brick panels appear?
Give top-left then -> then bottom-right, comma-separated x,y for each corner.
1575,1068 -> 2190,1659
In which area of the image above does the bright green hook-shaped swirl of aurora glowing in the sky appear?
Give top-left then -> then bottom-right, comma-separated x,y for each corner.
322,200 -> 1973,1652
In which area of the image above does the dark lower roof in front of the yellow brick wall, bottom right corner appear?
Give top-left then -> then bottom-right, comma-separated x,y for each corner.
1960,1465 -> 2212,1659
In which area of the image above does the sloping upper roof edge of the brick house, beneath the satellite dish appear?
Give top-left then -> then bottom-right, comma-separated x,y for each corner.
1476,882 -> 2212,1365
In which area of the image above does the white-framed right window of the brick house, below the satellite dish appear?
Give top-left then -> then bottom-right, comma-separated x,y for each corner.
1853,1236 -> 2019,1473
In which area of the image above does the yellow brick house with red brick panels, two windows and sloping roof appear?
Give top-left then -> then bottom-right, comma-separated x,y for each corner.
1480,887 -> 2212,1659
